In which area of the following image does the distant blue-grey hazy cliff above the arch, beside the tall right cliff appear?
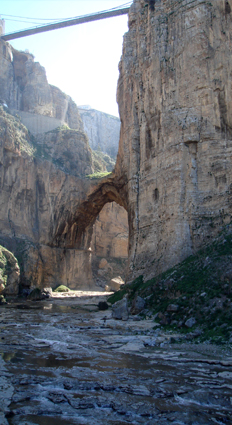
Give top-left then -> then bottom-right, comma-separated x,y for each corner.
79,107 -> 120,158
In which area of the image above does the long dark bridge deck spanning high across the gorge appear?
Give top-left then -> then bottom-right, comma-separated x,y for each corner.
0,7 -> 130,41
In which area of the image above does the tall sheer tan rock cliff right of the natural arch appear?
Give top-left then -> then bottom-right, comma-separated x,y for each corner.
116,0 -> 232,280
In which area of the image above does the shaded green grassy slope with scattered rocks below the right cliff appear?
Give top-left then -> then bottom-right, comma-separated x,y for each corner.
109,227 -> 232,343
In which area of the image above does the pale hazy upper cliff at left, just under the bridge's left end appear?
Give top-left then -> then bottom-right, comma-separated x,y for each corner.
0,40 -> 83,133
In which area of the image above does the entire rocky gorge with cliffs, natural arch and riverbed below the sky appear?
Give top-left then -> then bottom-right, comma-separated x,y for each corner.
0,0 -> 232,425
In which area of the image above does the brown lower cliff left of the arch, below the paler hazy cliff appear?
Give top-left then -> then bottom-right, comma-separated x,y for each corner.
0,108 -> 93,288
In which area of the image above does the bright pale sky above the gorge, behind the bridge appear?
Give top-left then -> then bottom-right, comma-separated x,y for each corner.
0,0 -> 131,116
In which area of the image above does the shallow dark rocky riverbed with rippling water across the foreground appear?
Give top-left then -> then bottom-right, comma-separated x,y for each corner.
0,292 -> 232,425
